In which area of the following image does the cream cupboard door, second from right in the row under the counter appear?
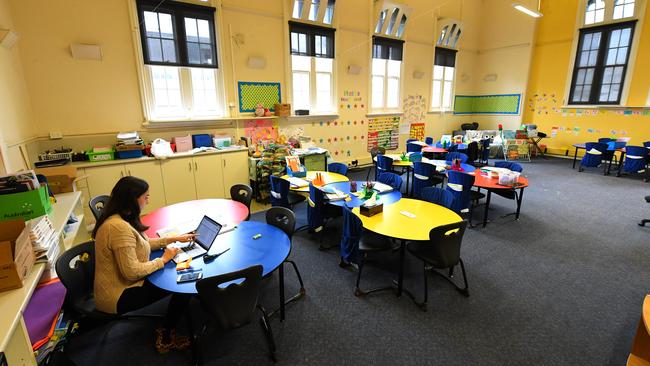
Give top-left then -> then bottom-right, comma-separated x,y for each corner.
194,154 -> 225,199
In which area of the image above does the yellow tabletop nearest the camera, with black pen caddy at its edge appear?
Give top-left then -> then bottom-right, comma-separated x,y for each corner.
352,198 -> 462,240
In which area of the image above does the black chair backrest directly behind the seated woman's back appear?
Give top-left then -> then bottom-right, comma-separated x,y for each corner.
55,241 -> 95,314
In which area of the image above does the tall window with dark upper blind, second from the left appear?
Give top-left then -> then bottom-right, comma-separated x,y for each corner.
289,22 -> 335,114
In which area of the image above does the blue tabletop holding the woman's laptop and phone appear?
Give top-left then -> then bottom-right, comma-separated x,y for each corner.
148,221 -> 291,294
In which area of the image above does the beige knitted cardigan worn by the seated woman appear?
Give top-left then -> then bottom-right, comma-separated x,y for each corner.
94,214 -> 166,314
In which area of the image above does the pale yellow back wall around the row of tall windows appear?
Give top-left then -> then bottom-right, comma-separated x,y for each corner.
3,0 -> 534,166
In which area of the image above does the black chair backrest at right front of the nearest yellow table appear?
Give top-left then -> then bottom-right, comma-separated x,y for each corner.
421,220 -> 467,268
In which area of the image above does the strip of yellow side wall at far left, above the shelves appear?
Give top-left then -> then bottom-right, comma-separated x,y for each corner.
0,0 -> 34,173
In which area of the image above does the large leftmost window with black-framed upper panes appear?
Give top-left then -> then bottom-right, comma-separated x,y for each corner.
137,0 -> 224,121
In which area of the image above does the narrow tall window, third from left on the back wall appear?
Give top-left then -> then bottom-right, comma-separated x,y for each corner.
371,36 -> 404,110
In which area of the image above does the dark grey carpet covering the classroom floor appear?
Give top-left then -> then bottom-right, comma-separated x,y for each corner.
67,159 -> 650,365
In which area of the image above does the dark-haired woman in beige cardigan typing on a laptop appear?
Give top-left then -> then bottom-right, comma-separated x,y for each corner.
93,176 -> 193,353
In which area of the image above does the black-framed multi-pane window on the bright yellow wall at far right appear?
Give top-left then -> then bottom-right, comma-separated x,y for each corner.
569,21 -> 636,104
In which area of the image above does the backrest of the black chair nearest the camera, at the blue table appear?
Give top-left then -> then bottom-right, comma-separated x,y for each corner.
196,265 -> 262,330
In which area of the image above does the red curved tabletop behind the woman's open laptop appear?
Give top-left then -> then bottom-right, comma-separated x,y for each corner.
142,199 -> 248,238
